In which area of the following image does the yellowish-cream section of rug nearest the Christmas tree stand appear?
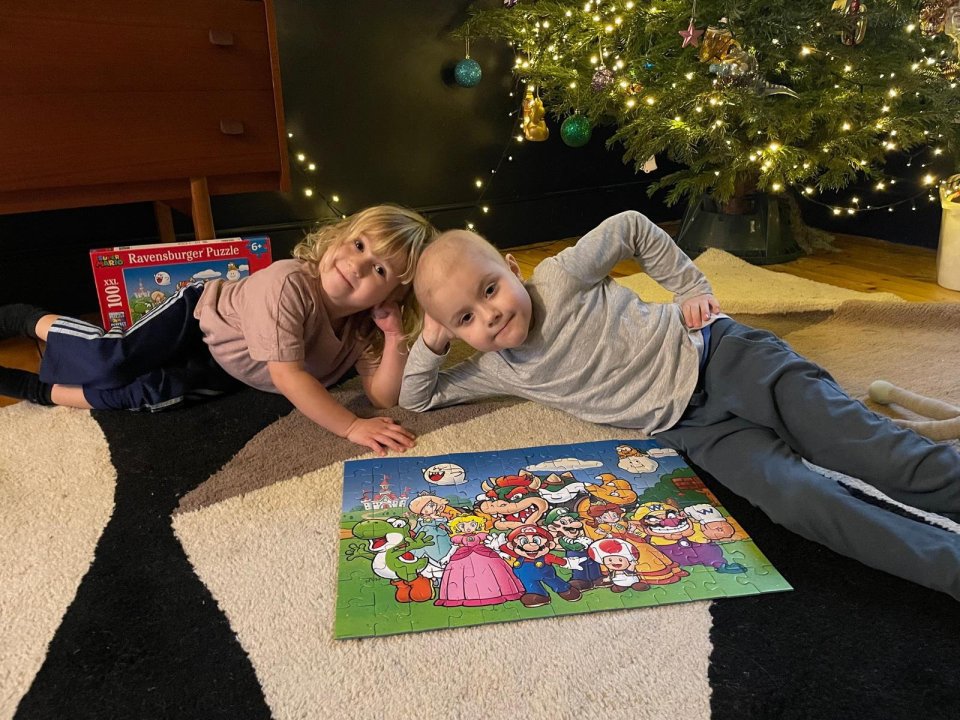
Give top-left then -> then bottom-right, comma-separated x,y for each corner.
617,248 -> 902,315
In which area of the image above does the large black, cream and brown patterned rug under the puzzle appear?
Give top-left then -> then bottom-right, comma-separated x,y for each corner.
0,302 -> 960,720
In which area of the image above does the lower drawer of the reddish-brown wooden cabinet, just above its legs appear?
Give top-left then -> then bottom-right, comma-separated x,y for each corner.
0,89 -> 282,192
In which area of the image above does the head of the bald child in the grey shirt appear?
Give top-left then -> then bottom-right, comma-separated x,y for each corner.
415,230 -> 533,352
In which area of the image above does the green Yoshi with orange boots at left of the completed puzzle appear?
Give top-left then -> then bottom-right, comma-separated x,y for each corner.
346,517 -> 433,603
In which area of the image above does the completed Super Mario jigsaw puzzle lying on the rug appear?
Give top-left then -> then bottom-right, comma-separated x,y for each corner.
335,440 -> 792,638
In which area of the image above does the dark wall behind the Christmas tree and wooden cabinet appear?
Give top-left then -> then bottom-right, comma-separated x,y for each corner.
0,0 -> 939,314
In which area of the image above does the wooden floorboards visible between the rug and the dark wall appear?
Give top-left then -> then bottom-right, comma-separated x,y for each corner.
0,233 -> 960,406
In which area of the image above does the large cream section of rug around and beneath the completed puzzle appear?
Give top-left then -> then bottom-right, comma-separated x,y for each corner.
173,403 -> 712,720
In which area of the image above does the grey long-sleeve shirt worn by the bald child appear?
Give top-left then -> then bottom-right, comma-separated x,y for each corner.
400,211 -> 712,435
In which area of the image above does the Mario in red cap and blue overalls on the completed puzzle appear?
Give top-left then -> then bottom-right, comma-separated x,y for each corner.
500,525 -> 581,607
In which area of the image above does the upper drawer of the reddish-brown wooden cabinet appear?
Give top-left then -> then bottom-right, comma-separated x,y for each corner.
0,0 -> 272,96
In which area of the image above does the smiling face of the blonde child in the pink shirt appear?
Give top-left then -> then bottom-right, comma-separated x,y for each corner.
320,234 -> 403,318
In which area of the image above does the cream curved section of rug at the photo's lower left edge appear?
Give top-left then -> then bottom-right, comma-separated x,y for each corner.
0,402 -> 117,718
